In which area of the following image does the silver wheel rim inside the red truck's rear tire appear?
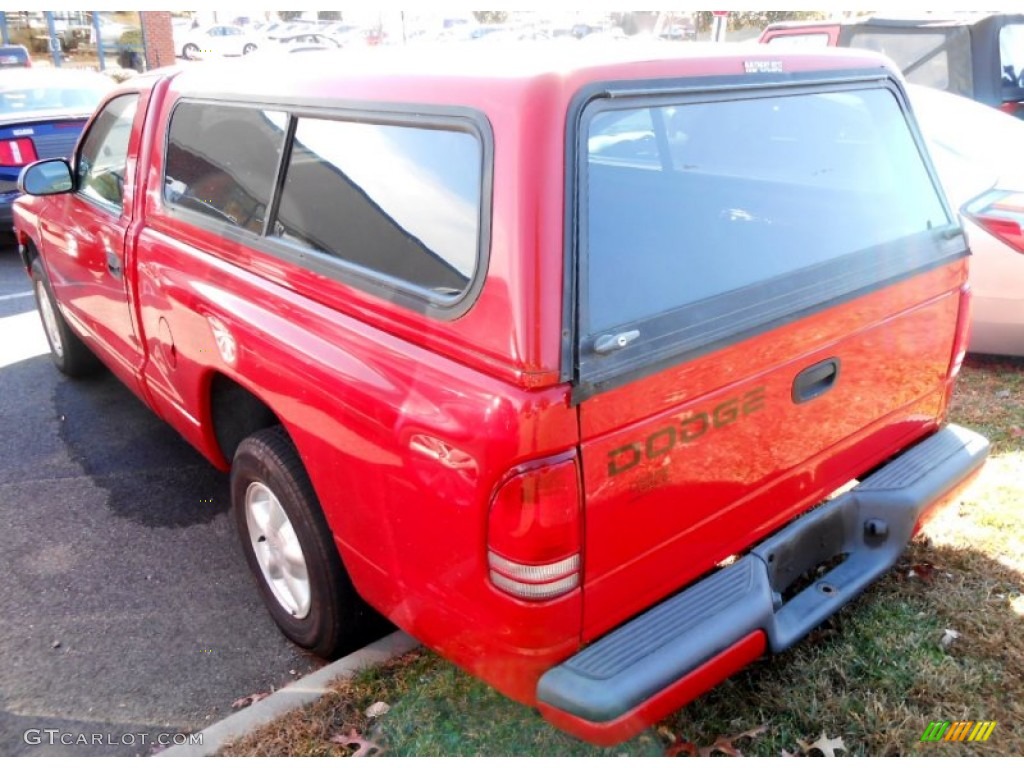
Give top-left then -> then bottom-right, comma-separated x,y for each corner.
246,482 -> 310,618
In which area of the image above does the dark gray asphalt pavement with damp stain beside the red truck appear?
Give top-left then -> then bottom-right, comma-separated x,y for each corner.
0,243 -> 321,756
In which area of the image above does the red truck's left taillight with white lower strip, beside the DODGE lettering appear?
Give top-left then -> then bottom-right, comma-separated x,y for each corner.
487,460 -> 582,600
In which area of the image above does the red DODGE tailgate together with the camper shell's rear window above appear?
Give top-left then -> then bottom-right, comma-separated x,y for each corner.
577,72 -> 966,640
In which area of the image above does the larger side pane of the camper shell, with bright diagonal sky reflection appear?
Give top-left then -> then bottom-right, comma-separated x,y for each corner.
270,117 -> 482,301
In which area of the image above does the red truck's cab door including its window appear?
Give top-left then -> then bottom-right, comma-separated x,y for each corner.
38,93 -> 144,389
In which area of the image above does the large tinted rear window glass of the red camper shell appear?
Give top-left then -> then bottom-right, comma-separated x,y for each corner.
580,87 -> 950,385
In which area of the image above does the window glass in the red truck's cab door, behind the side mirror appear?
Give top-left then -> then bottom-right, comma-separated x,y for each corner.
75,93 -> 138,211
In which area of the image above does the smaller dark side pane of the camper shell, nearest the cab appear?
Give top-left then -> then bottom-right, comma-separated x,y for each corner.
164,102 -> 287,234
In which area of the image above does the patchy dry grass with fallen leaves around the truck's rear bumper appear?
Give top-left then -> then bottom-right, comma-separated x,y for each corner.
225,357 -> 1024,756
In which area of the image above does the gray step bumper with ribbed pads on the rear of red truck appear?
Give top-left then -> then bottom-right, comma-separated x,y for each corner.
537,426 -> 988,723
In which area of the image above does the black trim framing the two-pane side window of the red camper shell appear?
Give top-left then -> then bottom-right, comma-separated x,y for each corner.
161,93 -> 494,321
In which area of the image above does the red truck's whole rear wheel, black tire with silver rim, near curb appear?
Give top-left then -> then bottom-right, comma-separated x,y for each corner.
231,427 -> 385,658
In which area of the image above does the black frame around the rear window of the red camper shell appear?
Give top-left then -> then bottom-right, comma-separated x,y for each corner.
561,68 -> 968,406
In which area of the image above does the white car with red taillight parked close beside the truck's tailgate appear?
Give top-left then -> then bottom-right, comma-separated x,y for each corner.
908,85 -> 1024,355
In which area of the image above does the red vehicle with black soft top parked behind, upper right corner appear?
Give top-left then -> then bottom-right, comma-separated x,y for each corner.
760,13 -> 1024,117
